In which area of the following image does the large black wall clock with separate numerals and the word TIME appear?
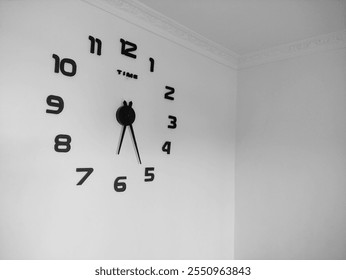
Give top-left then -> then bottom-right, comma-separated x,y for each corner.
46,35 -> 178,192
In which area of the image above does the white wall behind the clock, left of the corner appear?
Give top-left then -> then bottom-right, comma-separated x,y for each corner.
0,1 -> 236,259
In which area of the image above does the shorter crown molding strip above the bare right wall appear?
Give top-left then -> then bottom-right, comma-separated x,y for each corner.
238,29 -> 346,69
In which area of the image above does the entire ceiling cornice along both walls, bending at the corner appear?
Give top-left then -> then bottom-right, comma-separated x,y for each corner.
81,0 -> 346,69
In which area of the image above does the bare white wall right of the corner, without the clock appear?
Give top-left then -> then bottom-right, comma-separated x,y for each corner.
235,49 -> 346,259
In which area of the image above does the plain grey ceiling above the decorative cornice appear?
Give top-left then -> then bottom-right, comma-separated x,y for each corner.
138,0 -> 346,55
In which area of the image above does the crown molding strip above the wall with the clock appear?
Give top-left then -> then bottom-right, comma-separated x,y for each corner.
82,0 -> 239,69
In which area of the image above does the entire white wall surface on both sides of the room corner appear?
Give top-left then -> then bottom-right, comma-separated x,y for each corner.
0,0 -> 346,259
